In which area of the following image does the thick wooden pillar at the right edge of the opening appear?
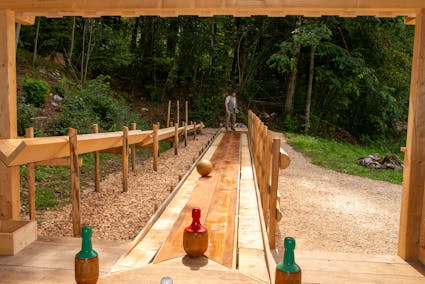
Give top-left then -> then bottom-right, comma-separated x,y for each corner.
398,9 -> 425,263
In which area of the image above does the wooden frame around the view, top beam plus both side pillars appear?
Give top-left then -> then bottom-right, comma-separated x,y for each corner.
0,0 -> 425,263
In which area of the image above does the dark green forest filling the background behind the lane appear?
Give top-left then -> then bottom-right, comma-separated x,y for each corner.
17,16 -> 414,147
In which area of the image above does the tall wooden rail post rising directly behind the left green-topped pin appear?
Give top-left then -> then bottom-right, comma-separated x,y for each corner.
68,128 -> 81,237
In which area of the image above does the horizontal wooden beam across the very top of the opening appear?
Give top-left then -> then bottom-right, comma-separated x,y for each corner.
0,0 -> 425,17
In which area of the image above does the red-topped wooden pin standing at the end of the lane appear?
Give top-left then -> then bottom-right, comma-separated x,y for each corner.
183,207 -> 208,257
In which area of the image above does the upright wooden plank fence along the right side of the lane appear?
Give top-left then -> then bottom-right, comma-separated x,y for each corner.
248,111 -> 291,249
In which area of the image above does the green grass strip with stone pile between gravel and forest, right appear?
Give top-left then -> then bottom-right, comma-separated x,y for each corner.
287,133 -> 403,184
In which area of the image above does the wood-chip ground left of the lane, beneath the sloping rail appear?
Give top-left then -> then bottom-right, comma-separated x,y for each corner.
37,128 -> 217,240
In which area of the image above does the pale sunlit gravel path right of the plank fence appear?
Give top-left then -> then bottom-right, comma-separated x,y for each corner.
278,139 -> 401,255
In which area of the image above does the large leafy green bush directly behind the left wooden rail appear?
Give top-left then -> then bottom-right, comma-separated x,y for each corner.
50,76 -> 145,135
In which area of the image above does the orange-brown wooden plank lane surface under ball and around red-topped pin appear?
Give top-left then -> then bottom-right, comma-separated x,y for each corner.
153,132 -> 240,268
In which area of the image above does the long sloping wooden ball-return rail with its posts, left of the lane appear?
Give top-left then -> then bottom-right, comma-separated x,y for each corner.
0,122 -> 204,236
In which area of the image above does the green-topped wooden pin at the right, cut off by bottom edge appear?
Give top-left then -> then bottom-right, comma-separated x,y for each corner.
275,237 -> 301,284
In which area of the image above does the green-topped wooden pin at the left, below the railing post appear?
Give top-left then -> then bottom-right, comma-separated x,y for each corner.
75,226 -> 99,284
